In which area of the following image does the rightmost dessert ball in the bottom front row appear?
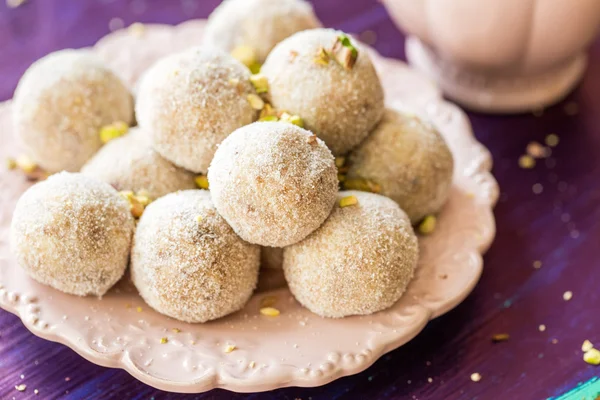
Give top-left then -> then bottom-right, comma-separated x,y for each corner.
283,191 -> 419,318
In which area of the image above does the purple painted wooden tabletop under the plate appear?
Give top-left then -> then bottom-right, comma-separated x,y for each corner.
0,0 -> 600,400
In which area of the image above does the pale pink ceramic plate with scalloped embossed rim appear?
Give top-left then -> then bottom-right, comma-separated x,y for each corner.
0,21 -> 498,392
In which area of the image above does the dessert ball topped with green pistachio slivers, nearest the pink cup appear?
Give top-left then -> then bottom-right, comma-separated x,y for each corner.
261,29 -> 384,155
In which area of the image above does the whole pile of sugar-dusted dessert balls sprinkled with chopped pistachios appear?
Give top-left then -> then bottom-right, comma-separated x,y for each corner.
11,0 -> 453,322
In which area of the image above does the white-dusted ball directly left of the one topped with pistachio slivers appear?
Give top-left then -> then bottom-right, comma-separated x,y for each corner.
136,47 -> 256,173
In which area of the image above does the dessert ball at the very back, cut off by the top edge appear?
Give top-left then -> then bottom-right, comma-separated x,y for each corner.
204,0 -> 321,63
